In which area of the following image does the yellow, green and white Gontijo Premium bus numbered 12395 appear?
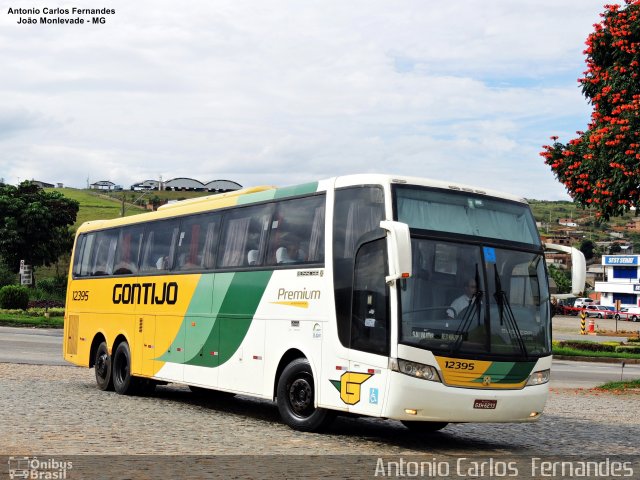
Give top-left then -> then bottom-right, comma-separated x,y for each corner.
63,174 -> 584,431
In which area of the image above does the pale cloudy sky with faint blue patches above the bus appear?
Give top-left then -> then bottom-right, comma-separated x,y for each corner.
0,0 -> 606,200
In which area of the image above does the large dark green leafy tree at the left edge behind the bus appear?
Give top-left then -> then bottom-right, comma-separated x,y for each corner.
0,181 -> 79,278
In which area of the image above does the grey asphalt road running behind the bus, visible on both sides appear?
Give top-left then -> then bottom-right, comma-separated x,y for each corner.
0,319 -> 640,388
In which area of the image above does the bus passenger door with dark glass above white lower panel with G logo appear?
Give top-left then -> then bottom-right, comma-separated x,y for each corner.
341,238 -> 391,415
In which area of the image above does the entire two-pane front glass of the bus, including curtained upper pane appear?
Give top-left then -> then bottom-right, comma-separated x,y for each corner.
395,186 -> 551,358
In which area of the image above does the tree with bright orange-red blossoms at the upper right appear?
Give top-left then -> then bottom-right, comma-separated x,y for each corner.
540,0 -> 640,219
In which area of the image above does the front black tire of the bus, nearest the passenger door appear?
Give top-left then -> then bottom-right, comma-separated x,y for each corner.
277,358 -> 335,432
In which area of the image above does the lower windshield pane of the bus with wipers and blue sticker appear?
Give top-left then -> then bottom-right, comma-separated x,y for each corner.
400,238 -> 551,358
